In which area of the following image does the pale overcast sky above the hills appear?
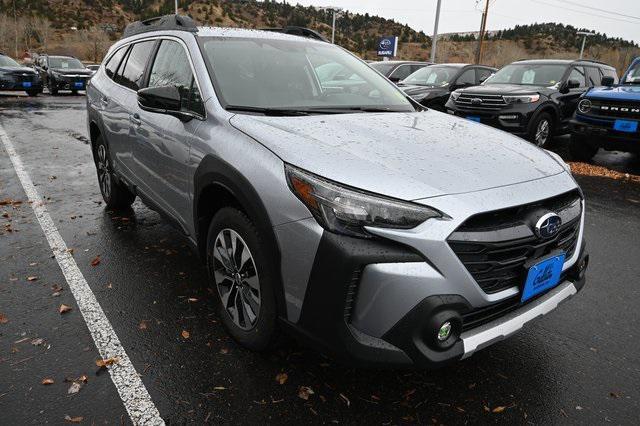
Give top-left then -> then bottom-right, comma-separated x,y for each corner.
287,0 -> 640,43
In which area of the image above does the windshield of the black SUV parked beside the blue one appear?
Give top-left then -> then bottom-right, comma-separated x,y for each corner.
484,64 -> 567,86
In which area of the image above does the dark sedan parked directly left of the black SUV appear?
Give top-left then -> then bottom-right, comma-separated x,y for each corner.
398,64 -> 497,111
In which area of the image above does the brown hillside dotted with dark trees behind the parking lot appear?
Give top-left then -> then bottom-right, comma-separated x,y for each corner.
0,0 -> 640,68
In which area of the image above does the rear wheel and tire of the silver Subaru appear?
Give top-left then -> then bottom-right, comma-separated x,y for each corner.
94,136 -> 136,210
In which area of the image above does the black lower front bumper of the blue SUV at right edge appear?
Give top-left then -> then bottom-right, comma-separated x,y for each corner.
569,114 -> 640,152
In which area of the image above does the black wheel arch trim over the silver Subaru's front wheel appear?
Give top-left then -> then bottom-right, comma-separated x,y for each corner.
193,155 -> 287,318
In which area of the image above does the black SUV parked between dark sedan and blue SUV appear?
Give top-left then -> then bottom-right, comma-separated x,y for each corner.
446,59 -> 616,146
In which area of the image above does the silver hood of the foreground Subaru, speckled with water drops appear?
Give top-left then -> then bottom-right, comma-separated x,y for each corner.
230,110 -> 564,200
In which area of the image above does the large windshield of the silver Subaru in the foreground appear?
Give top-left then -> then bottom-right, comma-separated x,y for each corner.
203,37 -> 415,112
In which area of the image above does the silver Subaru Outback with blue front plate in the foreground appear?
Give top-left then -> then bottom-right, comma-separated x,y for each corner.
87,15 -> 588,368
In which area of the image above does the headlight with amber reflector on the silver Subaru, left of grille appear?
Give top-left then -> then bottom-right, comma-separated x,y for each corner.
285,165 -> 443,238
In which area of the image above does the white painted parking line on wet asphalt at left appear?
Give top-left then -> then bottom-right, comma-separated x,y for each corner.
0,125 -> 164,425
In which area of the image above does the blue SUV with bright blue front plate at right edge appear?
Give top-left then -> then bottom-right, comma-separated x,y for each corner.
569,58 -> 640,161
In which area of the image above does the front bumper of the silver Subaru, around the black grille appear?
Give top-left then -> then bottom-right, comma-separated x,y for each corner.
278,173 -> 588,368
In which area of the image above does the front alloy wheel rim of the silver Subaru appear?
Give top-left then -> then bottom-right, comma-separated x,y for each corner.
213,229 -> 261,330
